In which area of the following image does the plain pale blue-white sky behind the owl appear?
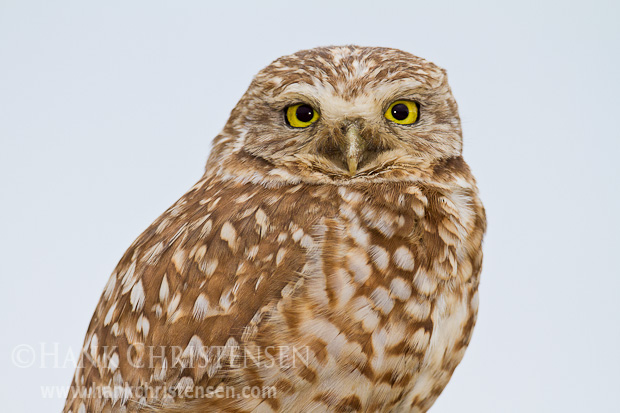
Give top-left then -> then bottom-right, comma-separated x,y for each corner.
0,0 -> 620,413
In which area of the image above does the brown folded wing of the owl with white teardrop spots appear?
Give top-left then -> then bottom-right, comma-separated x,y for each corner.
65,177 -> 324,412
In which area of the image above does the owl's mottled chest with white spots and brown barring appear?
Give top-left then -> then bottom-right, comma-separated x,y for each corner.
272,190 -> 473,403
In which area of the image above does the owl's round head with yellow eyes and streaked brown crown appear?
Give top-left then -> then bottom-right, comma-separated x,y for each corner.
207,46 -> 462,182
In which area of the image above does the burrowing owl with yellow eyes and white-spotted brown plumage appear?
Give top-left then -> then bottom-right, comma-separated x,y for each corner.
65,46 -> 485,413
